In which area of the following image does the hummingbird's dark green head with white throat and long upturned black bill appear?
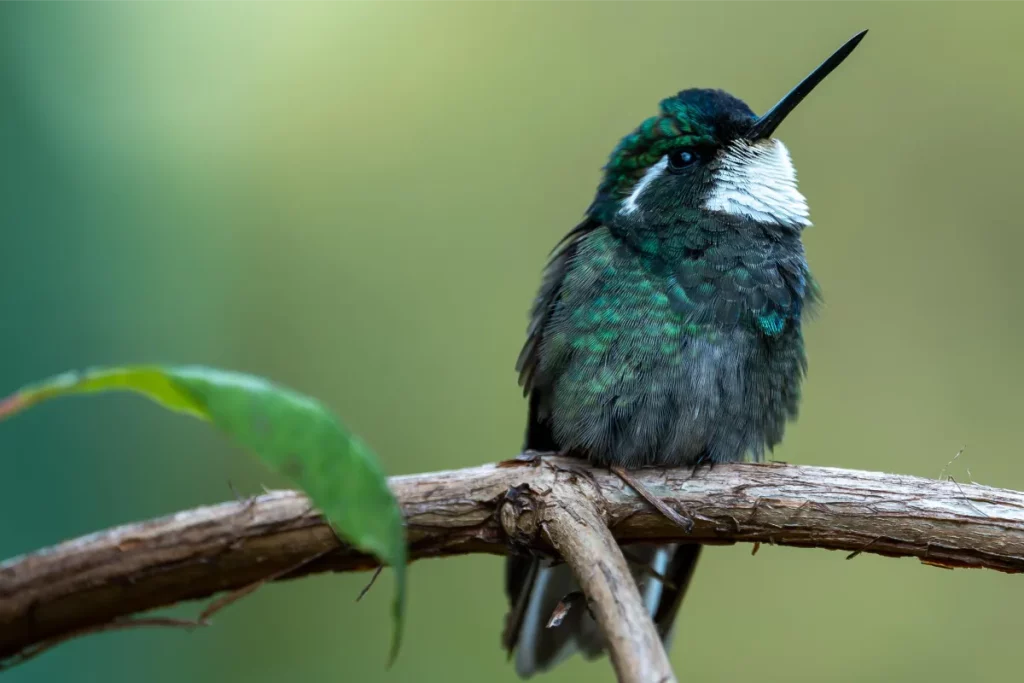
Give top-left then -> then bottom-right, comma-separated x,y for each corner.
590,31 -> 867,229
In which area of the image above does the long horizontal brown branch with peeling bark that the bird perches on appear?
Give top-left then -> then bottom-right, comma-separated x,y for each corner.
0,458 -> 1024,671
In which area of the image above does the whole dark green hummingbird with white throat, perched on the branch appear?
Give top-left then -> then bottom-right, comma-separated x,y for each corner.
503,31 -> 867,678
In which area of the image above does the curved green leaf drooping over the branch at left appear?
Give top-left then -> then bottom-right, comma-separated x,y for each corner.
0,366 -> 407,661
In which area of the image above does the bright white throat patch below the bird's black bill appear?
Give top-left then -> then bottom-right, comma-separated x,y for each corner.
704,139 -> 811,227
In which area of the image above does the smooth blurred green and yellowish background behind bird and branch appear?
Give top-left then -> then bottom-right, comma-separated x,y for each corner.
0,0 -> 1024,683
